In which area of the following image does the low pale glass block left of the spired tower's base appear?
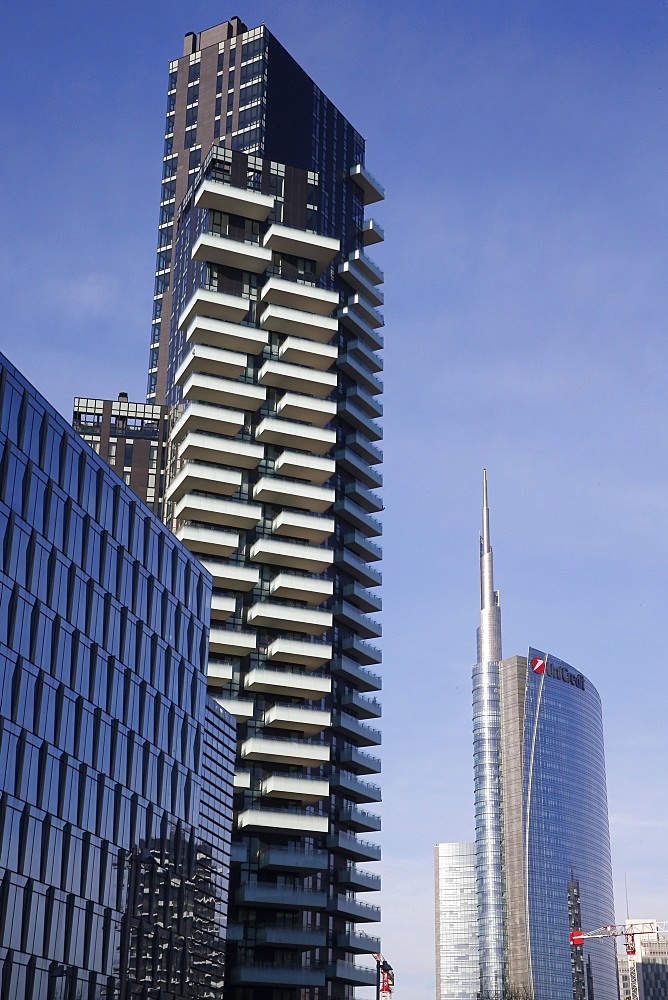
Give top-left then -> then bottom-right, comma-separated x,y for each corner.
434,843 -> 480,1000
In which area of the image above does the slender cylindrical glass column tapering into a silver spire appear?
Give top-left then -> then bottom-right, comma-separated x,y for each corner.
473,471 -> 504,994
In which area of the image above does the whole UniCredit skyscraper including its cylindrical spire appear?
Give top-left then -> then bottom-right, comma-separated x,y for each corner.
473,478 -> 618,1000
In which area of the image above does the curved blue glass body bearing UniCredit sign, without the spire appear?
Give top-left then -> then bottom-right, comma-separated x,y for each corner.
500,649 -> 617,1000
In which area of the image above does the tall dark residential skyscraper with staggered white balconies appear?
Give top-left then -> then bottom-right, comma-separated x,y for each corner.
148,19 -> 383,1000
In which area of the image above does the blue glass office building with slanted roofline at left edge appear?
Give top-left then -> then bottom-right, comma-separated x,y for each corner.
0,356 -> 234,1000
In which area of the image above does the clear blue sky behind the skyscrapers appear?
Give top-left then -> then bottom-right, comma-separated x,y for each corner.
0,0 -> 668,1000
